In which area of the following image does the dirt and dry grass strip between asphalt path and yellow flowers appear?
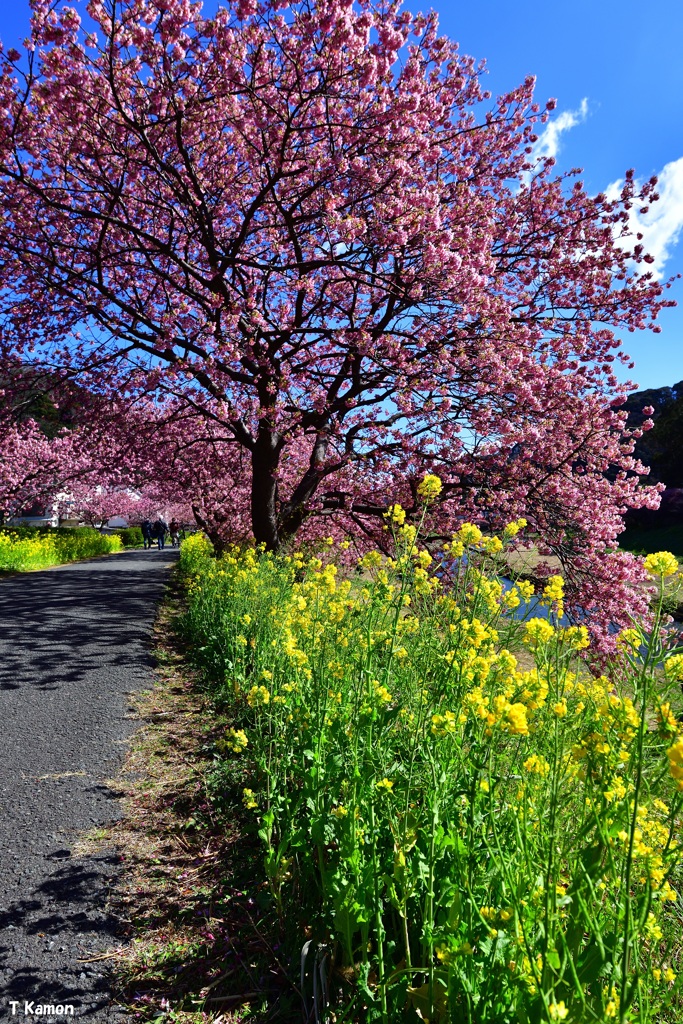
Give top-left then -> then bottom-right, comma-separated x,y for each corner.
75,583 -> 300,1024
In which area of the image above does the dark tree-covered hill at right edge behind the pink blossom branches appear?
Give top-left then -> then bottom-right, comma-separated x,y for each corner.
625,381 -> 683,487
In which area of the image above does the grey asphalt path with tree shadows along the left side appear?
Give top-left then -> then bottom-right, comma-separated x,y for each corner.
0,550 -> 177,1024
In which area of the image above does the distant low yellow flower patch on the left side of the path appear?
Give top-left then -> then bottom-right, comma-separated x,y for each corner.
0,526 -> 123,572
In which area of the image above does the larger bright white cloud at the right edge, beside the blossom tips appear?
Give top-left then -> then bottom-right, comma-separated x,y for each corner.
606,157 -> 683,278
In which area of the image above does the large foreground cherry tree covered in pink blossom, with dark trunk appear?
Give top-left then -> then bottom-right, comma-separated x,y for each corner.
0,0 -> 666,638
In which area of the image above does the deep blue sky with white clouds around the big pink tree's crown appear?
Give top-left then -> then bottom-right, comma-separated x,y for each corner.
0,0 -> 683,387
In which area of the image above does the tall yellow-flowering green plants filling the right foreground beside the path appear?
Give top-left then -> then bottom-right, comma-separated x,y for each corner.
153,477 -> 683,1024
